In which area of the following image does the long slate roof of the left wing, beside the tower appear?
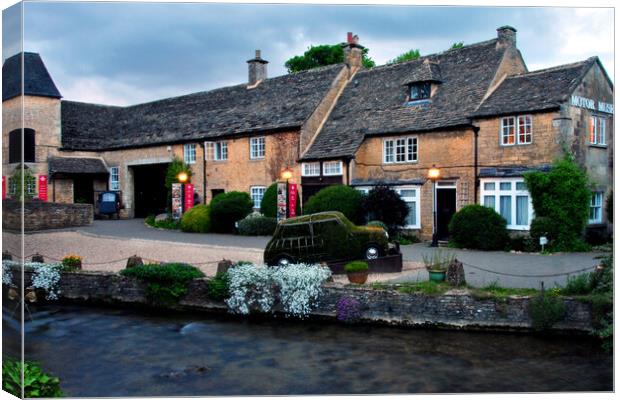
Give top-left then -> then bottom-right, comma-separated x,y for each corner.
61,64 -> 344,150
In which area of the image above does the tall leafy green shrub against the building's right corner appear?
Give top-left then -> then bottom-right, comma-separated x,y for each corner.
525,155 -> 592,251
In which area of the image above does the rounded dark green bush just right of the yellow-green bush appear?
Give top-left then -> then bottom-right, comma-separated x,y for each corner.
209,192 -> 254,233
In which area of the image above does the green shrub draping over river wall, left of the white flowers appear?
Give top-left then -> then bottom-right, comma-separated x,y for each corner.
120,263 -> 204,305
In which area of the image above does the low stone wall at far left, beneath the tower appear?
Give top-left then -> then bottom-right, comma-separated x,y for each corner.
2,200 -> 93,232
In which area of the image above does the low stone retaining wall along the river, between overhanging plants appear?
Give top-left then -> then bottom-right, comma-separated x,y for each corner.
16,271 -> 592,334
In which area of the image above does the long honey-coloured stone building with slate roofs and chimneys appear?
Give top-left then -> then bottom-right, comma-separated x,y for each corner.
2,27 -> 613,238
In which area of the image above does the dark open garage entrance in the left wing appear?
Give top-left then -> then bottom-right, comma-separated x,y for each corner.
131,163 -> 169,218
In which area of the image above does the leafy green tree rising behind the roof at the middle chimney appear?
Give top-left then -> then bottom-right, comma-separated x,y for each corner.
284,44 -> 375,73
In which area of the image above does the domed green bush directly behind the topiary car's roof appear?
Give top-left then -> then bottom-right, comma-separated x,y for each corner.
304,185 -> 364,223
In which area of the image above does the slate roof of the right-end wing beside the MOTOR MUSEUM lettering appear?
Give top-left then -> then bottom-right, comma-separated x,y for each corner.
474,57 -> 598,117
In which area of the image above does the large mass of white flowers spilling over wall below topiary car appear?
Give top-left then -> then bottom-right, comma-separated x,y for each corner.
226,264 -> 331,318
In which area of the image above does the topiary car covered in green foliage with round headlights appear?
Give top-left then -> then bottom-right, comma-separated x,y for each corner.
264,211 -> 399,265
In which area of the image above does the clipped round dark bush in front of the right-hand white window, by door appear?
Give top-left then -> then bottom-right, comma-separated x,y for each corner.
448,204 -> 508,250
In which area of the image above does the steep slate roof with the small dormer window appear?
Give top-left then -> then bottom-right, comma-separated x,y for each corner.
303,39 -> 505,160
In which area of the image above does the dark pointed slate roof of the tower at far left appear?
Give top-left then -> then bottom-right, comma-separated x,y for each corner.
2,52 -> 62,101
